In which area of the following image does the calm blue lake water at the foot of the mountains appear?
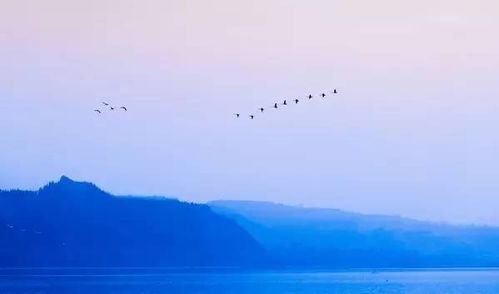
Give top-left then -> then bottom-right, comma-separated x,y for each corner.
0,268 -> 499,294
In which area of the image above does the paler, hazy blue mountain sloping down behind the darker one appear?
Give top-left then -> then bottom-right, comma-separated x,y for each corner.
209,201 -> 499,268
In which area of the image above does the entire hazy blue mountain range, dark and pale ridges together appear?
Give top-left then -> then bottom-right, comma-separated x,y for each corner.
0,177 -> 499,268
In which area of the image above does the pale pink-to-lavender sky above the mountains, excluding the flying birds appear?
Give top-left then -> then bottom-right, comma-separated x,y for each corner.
0,0 -> 499,225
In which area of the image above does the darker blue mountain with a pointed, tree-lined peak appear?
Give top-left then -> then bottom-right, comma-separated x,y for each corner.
0,177 -> 265,267
